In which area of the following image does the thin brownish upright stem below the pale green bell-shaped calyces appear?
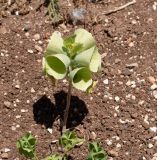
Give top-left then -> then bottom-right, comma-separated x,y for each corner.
62,80 -> 72,133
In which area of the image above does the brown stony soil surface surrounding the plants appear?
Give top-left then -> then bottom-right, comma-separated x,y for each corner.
0,0 -> 157,160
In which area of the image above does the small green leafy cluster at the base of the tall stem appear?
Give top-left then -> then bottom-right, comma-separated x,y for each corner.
59,130 -> 84,151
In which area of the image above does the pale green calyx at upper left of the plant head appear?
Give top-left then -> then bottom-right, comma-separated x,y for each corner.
45,31 -> 65,55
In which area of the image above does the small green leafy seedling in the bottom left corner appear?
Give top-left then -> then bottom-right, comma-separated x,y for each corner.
16,133 -> 36,158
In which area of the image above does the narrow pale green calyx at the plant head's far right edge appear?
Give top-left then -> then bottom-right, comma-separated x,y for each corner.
89,48 -> 101,72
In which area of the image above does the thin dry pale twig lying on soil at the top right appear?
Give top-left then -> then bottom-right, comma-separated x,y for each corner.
101,0 -> 136,15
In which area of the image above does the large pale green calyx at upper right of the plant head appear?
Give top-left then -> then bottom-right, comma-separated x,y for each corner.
74,28 -> 95,51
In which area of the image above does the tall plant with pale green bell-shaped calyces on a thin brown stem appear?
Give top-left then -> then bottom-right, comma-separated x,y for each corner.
43,29 -> 101,132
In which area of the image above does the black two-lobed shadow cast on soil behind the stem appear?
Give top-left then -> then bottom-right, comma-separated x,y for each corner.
33,91 -> 88,128
